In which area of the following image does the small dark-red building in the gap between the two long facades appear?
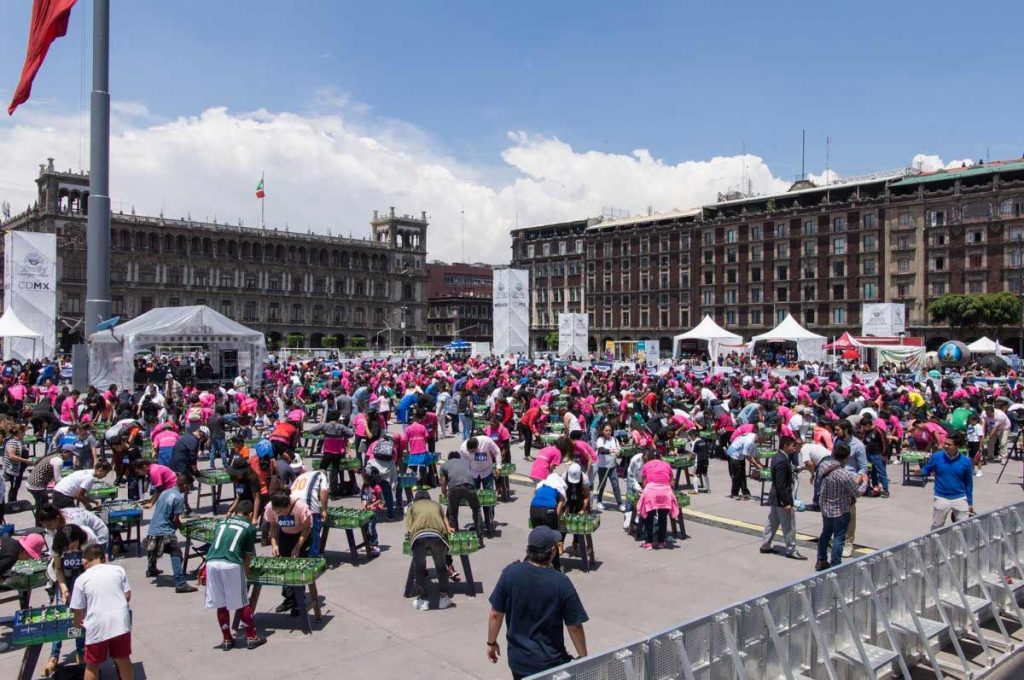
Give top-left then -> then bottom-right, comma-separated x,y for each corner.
427,262 -> 494,345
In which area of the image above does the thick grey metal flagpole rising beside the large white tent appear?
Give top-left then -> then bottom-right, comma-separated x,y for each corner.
74,0 -> 111,385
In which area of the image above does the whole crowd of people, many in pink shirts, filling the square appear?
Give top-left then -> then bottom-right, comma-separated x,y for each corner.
0,355 -> 1024,678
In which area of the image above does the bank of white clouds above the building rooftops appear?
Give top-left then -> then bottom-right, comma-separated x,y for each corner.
0,98 -> 958,263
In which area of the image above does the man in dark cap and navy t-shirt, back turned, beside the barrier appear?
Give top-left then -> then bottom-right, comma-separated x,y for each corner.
486,526 -> 589,680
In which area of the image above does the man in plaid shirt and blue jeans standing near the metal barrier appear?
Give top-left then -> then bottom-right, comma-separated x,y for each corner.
805,443 -> 859,571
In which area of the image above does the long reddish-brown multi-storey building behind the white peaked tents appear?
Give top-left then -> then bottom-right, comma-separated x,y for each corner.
512,161 -> 1024,351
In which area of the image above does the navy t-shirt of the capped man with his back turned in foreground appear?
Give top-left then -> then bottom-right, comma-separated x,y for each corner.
490,561 -> 589,677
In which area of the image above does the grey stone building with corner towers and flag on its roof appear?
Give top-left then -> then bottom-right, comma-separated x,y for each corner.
0,159 -> 427,350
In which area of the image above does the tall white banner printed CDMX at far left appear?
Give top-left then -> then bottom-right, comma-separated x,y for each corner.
3,231 -> 57,362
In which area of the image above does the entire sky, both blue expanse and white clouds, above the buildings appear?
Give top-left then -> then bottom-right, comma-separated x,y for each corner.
0,0 -> 1024,263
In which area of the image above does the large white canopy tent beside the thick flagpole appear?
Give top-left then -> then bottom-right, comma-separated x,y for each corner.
89,305 -> 266,387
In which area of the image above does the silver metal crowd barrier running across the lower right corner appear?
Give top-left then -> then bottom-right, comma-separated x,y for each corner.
531,503 -> 1024,680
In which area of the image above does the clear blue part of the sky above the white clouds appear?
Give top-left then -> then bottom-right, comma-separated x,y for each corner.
0,0 -> 1024,261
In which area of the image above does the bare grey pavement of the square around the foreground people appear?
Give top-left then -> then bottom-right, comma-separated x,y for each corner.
0,430 -> 1022,679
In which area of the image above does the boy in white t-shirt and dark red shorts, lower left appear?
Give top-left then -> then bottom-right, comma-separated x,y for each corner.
69,546 -> 135,680
